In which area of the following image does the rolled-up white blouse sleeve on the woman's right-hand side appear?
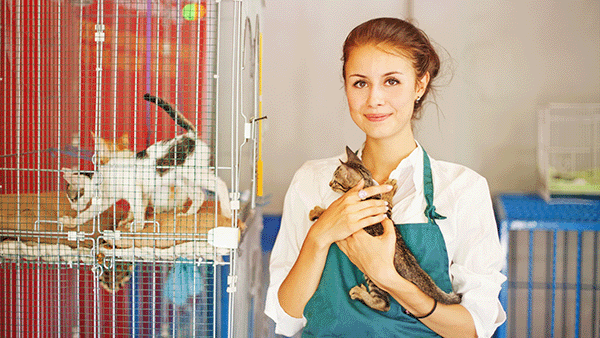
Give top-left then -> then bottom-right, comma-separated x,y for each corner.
450,177 -> 506,337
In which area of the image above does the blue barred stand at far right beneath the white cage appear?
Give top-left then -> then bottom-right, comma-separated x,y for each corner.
495,194 -> 600,337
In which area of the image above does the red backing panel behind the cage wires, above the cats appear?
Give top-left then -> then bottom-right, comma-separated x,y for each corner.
0,0 -> 207,193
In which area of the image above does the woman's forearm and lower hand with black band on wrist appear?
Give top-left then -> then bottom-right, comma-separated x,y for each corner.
337,219 -> 477,337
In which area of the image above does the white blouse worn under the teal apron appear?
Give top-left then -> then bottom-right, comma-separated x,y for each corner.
265,145 -> 506,337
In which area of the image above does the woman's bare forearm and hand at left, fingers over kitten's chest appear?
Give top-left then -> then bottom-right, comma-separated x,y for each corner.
277,183 -> 391,318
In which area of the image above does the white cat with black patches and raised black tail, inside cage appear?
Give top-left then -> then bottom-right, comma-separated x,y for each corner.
59,94 -> 231,231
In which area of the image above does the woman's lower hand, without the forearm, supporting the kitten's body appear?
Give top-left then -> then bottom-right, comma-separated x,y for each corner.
336,217 -> 400,288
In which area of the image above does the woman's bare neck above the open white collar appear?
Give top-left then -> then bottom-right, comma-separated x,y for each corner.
362,138 -> 417,184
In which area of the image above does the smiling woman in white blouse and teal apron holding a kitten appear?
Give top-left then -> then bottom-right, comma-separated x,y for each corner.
265,18 -> 506,337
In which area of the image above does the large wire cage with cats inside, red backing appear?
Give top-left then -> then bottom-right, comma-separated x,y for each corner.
0,0 -> 258,337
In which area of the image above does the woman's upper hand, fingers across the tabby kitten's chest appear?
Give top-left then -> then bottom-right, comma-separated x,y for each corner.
307,181 -> 392,248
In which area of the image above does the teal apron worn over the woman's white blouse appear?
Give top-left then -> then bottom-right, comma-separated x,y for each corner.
302,150 -> 452,338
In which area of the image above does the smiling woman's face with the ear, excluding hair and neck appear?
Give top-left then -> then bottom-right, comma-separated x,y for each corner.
344,45 -> 429,141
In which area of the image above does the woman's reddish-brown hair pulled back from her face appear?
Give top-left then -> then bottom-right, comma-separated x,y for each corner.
342,18 -> 440,119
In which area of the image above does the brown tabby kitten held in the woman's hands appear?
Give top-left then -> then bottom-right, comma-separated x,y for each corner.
309,147 -> 461,311
